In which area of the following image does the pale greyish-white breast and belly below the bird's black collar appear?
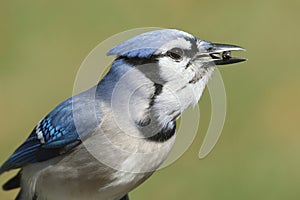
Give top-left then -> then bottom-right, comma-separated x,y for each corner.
22,124 -> 175,200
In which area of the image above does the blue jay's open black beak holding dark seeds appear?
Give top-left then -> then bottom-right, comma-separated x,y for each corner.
206,43 -> 247,65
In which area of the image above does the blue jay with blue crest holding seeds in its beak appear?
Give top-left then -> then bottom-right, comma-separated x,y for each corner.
0,29 -> 246,200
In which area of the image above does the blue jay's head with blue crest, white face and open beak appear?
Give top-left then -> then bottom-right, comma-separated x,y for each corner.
108,29 -> 245,130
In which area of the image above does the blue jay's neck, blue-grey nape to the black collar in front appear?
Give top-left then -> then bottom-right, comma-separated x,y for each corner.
97,59 -> 180,142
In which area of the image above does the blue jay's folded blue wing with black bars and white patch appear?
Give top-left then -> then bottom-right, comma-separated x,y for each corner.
0,87 -> 101,174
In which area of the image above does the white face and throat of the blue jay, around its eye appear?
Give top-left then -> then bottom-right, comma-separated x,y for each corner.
148,38 -> 214,122
